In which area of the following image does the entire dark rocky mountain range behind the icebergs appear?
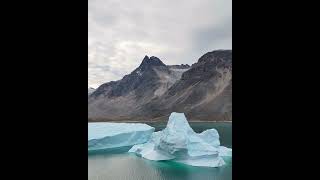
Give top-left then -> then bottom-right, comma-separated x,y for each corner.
88,50 -> 232,121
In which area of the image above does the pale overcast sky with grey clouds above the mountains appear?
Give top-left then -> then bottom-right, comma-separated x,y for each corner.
88,0 -> 232,87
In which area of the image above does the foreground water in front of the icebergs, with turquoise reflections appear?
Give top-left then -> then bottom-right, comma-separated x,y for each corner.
88,153 -> 232,180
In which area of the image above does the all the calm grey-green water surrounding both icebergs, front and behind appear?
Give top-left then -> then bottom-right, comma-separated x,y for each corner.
88,123 -> 232,180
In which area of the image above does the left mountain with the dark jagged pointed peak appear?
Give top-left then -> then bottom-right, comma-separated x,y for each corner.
88,56 -> 181,120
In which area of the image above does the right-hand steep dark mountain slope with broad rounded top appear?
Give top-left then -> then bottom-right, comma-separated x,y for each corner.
144,51 -> 232,121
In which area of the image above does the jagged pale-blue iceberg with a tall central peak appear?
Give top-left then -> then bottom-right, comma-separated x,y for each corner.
129,113 -> 232,167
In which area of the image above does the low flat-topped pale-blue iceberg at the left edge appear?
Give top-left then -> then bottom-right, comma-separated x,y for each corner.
88,123 -> 154,151
